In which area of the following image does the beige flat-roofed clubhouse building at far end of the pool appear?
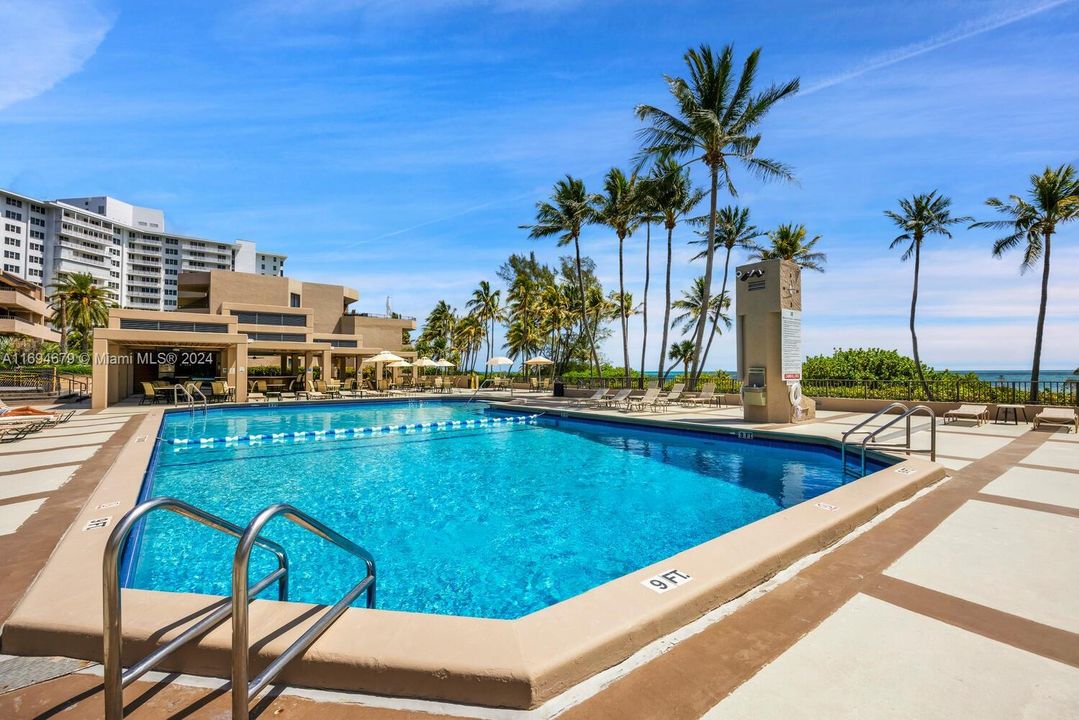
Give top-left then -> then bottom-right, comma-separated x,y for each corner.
93,270 -> 415,409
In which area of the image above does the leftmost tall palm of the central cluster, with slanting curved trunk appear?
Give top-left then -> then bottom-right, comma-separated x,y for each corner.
521,175 -> 600,373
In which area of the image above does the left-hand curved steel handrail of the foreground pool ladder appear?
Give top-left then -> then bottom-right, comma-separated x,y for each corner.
101,498 -> 288,720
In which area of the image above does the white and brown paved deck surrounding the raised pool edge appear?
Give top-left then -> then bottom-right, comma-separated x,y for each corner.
0,390 -> 1079,720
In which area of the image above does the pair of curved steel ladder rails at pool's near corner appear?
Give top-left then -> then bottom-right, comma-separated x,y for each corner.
103,498 -> 375,720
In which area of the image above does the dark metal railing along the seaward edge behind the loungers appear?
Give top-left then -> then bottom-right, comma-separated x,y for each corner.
556,372 -> 1079,406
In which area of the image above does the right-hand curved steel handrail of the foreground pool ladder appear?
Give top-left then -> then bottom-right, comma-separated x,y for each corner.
232,503 -> 375,720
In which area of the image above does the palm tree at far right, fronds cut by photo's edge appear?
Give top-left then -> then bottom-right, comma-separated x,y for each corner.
971,165 -> 1079,403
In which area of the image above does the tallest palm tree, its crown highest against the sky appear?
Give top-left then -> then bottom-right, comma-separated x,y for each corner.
637,45 -> 798,386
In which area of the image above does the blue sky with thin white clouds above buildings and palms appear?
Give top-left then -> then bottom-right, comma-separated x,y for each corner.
0,0 -> 1079,369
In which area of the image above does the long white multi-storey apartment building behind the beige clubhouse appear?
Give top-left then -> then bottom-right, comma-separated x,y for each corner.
0,188 -> 287,310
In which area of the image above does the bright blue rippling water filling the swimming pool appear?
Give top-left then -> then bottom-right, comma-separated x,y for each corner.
127,400 -> 878,619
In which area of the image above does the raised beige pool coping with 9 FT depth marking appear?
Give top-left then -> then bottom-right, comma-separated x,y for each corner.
2,403 -> 945,709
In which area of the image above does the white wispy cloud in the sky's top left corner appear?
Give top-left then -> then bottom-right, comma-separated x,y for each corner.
0,0 -> 114,110
